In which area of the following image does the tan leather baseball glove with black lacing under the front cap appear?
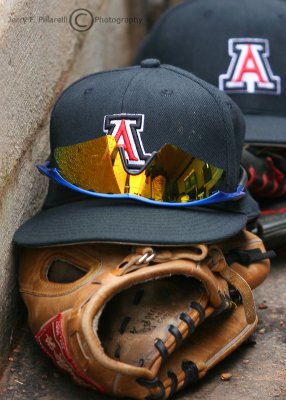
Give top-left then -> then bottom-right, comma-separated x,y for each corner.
19,231 -> 270,400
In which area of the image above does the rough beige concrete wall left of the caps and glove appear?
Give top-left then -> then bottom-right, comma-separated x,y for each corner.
0,0 -> 144,367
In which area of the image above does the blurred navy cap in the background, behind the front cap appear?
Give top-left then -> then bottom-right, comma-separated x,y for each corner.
135,0 -> 286,146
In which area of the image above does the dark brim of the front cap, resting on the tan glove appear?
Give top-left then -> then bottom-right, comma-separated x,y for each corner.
14,194 -> 259,247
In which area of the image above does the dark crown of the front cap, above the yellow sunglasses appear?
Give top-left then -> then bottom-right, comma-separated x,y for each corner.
51,60 -> 244,191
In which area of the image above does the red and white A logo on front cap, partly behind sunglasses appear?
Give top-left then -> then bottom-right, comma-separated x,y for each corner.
103,114 -> 152,172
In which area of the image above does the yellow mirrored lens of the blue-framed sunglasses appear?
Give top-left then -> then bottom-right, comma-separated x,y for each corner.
54,135 -> 223,202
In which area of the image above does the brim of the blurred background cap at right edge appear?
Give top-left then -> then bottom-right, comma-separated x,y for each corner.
244,114 -> 286,147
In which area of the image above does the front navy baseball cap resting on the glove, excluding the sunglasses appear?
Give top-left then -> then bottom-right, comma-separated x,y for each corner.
14,59 -> 259,247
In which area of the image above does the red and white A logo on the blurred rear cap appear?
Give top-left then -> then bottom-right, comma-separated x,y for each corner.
219,38 -> 281,95
